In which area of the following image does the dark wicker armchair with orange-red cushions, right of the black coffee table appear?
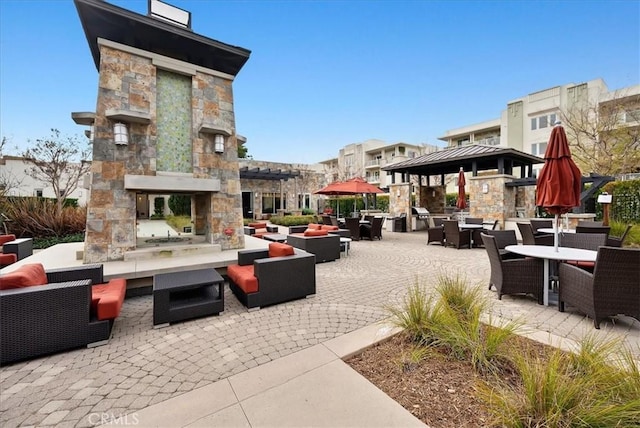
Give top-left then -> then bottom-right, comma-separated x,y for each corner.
227,242 -> 316,309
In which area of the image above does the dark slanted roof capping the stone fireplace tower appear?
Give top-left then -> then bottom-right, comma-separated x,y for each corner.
74,0 -> 251,76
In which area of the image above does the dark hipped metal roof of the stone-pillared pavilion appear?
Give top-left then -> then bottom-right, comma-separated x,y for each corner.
382,144 -> 544,176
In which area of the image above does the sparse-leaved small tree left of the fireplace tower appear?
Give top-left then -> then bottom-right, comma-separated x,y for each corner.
22,129 -> 91,213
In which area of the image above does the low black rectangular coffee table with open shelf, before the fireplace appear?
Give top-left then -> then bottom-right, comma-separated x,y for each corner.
153,269 -> 224,328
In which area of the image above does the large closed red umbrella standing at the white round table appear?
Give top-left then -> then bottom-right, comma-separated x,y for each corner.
536,123 -> 582,251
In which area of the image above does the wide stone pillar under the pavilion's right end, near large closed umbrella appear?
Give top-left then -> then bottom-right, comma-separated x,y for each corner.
467,174 -> 517,229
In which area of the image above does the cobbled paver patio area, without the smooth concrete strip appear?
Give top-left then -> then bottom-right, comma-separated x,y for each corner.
0,232 -> 640,427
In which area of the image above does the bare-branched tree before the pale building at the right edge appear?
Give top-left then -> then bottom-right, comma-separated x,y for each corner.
561,92 -> 640,175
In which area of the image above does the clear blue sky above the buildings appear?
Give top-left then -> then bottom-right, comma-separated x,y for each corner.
0,0 -> 640,163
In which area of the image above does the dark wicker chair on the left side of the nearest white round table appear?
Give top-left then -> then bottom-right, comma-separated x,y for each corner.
480,233 -> 544,304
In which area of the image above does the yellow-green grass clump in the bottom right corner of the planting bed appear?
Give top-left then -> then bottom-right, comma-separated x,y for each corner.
478,336 -> 640,427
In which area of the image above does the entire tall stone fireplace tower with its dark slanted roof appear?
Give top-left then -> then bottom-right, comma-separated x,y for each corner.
72,0 -> 250,263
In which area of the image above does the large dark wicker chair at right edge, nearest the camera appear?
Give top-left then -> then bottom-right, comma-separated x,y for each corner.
558,247 -> 640,329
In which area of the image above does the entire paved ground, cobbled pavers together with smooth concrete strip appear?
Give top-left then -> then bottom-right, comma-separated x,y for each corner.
0,232 -> 640,427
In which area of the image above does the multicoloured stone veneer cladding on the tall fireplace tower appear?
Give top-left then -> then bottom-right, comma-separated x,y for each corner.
84,45 -> 244,263
